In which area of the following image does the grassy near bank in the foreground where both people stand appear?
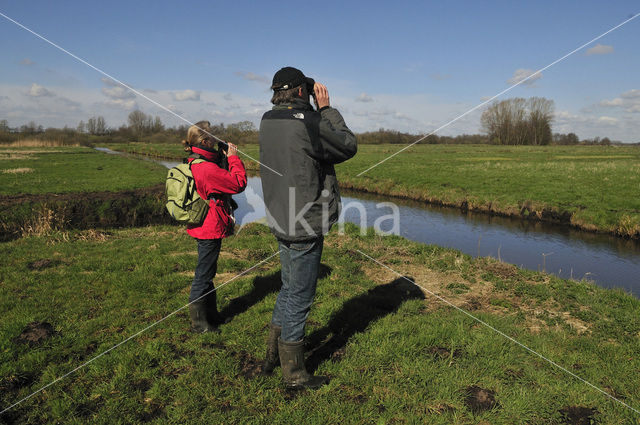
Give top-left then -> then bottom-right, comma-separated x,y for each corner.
0,225 -> 640,424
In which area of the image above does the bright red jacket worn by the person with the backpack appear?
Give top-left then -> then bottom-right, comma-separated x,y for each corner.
187,147 -> 247,239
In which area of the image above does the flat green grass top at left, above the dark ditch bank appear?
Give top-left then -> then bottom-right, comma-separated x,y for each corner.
0,147 -> 167,195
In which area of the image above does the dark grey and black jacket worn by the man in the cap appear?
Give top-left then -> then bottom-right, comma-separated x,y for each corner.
260,97 -> 357,241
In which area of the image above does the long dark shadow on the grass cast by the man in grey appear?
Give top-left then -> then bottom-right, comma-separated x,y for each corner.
306,276 -> 425,372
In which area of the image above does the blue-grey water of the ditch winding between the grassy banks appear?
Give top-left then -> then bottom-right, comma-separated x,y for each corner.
98,148 -> 640,296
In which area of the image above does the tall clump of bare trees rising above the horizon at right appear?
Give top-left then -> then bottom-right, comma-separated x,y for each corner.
480,97 -> 554,145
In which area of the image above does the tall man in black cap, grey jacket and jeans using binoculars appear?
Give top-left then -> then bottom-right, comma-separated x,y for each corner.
260,67 -> 357,388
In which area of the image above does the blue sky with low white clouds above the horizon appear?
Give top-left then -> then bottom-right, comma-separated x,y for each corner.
0,1 -> 640,142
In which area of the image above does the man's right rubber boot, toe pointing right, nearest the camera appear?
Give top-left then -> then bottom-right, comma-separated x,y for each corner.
278,338 -> 329,390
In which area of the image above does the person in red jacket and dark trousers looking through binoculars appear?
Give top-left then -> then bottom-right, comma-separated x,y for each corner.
182,121 -> 247,333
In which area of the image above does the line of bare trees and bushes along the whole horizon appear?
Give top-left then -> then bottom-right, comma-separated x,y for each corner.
0,97 -> 616,145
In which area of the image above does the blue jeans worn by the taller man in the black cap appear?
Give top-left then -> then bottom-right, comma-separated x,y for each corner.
271,236 -> 324,342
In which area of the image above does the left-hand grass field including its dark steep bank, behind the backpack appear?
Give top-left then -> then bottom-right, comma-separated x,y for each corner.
0,146 -> 169,241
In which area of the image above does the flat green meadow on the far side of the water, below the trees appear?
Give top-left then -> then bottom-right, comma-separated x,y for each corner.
99,143 -> 640,238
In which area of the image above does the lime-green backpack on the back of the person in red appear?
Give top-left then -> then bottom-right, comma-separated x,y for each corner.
165,159 -> 209,224
